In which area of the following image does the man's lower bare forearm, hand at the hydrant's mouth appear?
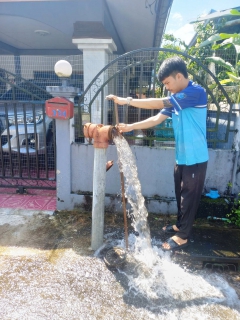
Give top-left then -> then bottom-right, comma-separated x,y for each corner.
118,113 -> 168,132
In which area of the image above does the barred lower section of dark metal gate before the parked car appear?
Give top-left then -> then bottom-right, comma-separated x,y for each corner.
0,100 -> 56,193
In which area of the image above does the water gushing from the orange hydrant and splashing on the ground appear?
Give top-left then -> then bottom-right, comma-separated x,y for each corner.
114,137 -> 240,319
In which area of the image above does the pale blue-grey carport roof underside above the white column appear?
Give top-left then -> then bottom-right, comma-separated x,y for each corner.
0,0 -> 173,55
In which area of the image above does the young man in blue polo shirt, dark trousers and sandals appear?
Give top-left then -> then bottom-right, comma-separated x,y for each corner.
106,57 -> 208,251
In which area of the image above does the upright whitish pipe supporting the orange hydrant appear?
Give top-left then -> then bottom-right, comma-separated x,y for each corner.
91,148 -> 107,250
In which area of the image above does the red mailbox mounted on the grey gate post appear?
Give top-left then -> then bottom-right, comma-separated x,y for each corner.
45,97 -> 74,120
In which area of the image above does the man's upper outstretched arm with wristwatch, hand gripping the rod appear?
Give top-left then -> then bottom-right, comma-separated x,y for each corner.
106,94 -> 172,109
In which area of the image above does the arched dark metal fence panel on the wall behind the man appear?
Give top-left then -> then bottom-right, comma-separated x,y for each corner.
75,48 -> 235,149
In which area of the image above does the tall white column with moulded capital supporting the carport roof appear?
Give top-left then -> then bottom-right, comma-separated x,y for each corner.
72,38 -> 117,124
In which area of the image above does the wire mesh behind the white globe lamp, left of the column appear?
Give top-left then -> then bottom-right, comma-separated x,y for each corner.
0,55 -> 83,101
